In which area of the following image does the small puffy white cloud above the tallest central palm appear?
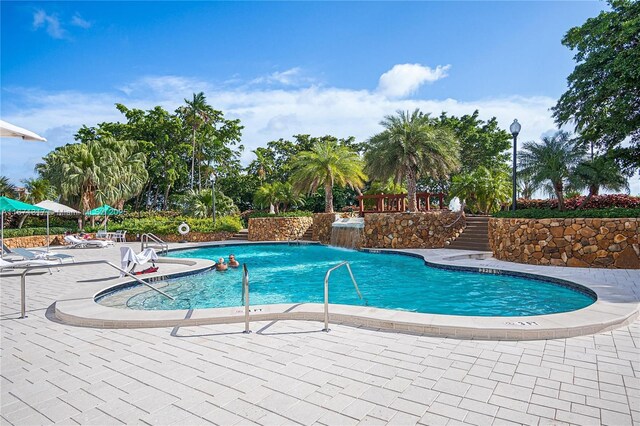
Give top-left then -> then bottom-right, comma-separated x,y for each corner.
378,64 -> 451,98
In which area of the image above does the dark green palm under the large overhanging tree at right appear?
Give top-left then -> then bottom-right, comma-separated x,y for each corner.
574,155 -> 629,205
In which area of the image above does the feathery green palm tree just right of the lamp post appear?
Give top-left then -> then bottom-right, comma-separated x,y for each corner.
518,130 -> 585,210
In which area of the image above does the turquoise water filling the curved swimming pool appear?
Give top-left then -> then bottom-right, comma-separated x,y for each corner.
107,244 -> 594,316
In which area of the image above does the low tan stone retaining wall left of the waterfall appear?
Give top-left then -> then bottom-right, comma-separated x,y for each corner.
248,217 -> 313,241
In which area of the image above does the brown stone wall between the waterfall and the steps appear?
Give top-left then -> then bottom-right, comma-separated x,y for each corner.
363,211 -> 465,248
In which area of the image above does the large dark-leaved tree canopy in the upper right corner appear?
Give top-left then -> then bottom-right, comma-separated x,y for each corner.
553,0 -> 640,168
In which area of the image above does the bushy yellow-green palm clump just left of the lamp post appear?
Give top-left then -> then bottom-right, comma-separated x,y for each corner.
450,166 -> 511,214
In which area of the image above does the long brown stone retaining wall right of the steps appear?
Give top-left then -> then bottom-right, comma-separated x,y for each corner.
489,218 -> 640,269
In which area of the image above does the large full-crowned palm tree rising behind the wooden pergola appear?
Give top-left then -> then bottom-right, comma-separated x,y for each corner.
364,109 -> 460,212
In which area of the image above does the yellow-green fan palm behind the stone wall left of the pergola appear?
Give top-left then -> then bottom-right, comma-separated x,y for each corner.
291,140 -> 367,213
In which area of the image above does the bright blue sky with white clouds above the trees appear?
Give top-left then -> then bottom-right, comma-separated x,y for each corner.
0,1 -> 639,192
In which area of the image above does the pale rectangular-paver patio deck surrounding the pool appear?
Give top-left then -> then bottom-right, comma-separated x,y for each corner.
0,243 -> 640,425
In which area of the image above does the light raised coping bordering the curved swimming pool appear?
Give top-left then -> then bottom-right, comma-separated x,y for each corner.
55,241 -> 640,340
